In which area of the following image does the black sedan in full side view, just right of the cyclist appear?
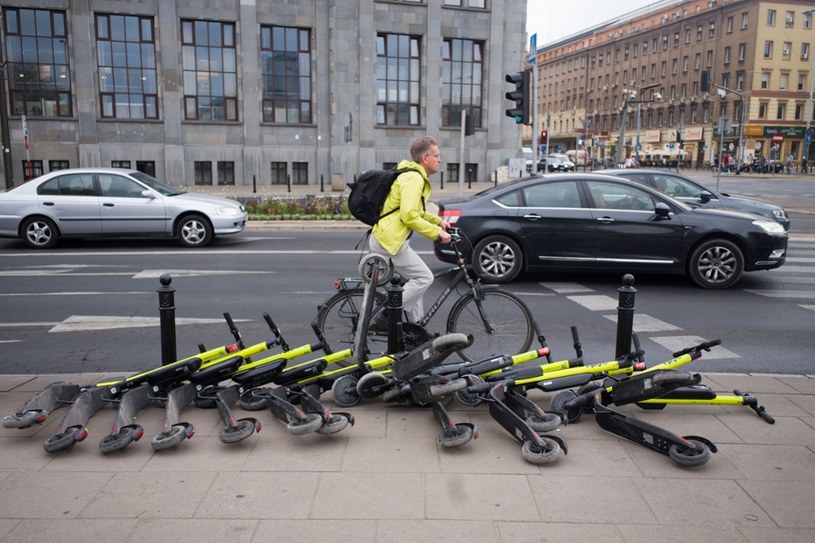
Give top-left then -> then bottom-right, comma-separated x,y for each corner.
435,174 -> 787,289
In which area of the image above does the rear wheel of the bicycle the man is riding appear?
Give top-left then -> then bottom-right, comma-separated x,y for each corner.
317,290 -> 387,365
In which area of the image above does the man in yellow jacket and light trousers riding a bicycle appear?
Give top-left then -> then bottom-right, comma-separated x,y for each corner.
369,137 -> 450,331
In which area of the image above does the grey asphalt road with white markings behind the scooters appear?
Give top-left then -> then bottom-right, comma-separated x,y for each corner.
0,228 -> 815,373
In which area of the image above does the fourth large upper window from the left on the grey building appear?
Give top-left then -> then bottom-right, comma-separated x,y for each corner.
260,26 -> 312,123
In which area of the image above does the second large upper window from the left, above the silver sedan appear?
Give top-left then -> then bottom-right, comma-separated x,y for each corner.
96,15 -> 158,119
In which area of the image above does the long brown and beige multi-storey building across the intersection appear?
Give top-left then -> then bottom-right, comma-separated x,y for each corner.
527,0 -> 815,166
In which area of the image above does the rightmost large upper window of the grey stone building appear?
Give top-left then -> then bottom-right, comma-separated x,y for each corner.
441,39 -> 484,128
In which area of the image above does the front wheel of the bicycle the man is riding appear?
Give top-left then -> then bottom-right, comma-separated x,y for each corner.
447,290 -> 535,362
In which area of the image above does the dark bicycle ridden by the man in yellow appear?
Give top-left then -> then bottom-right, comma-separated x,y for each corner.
317,229 -> 536,362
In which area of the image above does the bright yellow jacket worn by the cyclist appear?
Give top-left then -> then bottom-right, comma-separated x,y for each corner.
372,160 -> 441,255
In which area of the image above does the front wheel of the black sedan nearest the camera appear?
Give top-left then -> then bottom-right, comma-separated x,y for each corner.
688,239 -> 744,290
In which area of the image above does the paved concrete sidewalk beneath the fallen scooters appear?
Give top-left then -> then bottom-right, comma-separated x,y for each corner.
0,374 -> 815,543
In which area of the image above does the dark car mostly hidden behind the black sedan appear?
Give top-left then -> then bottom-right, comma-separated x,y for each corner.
596,168 -> 790,230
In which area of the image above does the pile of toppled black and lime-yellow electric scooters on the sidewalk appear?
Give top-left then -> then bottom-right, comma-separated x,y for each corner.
2,296 -> 774,466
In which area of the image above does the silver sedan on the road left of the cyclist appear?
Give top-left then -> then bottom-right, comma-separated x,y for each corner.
0,168 -> 248,249
